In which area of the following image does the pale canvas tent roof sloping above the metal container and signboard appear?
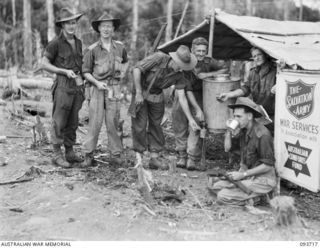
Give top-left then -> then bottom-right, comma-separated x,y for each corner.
158,11 -> 320,70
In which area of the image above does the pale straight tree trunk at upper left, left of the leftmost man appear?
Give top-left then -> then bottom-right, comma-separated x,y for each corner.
23,0 -> 32,70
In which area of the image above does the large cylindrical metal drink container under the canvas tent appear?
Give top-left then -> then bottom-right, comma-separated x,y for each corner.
203,74 -> 240,133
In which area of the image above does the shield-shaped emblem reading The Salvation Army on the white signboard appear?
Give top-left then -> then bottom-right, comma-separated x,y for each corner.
285,79 -> 316,120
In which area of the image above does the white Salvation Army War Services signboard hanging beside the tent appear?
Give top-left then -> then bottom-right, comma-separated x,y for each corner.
274,71 -> 320,192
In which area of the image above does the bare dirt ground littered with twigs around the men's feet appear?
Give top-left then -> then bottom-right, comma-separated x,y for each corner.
0,87 -> 320,241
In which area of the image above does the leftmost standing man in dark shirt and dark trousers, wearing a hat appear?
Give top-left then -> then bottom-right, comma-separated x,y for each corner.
42,8 -> 84,167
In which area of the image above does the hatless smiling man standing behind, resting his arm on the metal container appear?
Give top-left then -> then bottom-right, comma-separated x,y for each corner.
172,37 -> 227,170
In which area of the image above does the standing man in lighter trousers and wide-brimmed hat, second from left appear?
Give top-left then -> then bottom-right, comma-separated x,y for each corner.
82,14 -> 128,166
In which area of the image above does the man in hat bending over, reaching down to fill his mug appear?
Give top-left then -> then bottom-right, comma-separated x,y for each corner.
129,46 -> 200,169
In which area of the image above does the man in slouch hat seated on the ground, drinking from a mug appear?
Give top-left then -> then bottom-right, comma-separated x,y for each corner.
212,97 -> 276,205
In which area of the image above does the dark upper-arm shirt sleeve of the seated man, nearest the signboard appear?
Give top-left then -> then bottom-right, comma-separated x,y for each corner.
258,135 -> 275,166
